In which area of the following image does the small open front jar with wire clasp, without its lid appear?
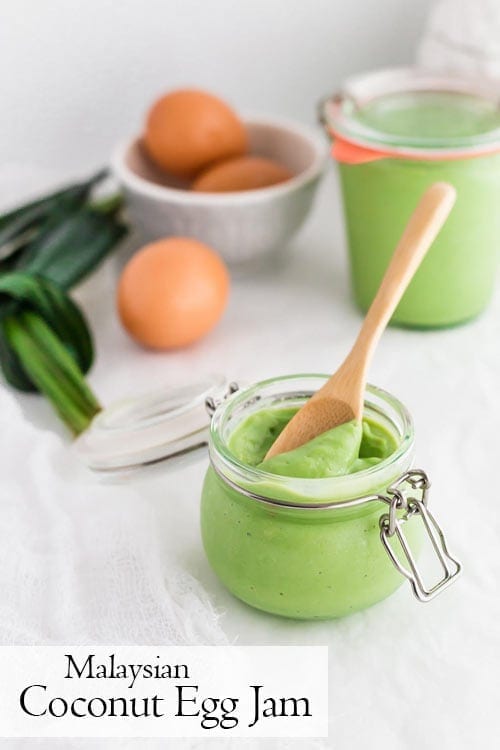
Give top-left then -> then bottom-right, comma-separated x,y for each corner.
201,375 -> 459,619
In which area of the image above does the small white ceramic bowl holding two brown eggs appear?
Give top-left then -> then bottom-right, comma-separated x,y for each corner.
112,119 -> 327,265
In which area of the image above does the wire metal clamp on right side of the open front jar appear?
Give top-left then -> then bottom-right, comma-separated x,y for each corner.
380,469 -> 462,602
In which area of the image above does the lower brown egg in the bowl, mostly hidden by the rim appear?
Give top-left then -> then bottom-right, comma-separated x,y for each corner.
191,156 -> 293,193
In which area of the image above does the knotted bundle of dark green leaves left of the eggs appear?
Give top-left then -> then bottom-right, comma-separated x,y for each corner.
0,167 -> 127,434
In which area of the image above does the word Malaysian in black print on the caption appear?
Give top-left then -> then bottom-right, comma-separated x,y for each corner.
64,654 -> 190,689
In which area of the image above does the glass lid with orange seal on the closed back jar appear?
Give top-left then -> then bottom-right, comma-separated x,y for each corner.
320,68 -> 500,161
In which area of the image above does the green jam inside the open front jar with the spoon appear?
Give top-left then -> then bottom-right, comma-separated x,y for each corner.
201,396 -> 420,619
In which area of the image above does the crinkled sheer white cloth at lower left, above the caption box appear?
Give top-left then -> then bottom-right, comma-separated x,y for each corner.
0,387 -> 226,645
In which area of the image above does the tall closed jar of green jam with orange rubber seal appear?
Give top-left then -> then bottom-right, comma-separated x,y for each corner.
321,69 -> 500,328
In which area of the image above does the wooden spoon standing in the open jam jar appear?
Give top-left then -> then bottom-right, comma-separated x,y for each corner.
266,182 -> 456,458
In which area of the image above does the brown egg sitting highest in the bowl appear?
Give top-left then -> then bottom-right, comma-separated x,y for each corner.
144,89 -> 248,178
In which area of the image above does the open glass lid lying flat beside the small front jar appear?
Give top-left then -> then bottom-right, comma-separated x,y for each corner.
73,374 -> 227,471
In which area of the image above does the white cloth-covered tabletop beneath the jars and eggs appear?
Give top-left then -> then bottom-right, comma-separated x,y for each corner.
0,157 -> 500,750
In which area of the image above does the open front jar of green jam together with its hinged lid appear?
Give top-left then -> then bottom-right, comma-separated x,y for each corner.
74,375 -> 460,619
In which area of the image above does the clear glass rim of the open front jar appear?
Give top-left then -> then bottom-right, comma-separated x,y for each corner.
209,373 -> 414,510
